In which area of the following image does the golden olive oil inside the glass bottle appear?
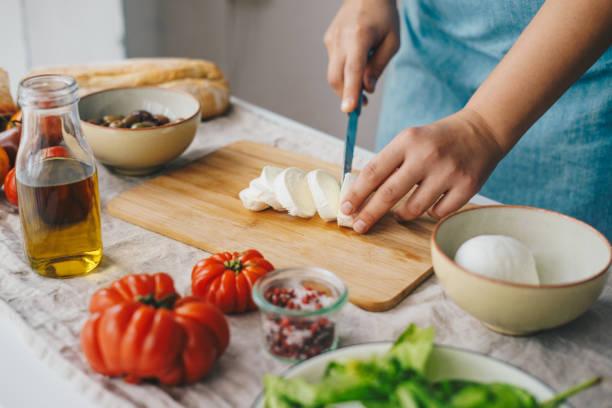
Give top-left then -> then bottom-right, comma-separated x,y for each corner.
17,157 -> 102,278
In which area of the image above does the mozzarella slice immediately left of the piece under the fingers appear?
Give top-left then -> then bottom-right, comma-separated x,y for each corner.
306,169 -> 340,222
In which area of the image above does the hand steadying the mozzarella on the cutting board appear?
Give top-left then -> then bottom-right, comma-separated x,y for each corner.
340,109 -> 507,234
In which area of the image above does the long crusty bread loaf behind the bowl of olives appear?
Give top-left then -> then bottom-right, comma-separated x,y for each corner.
29,58 -> 230,119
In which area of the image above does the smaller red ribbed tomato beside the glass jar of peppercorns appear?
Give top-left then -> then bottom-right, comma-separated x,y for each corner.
191,249 -> 274,313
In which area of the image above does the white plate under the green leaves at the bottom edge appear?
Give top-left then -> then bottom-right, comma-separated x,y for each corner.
252,342 -> 571,408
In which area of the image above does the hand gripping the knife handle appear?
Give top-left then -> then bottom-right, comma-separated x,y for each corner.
323,0 -> 400,113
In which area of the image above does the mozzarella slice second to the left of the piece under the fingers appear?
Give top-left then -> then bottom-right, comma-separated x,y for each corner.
274,167 -> 317,218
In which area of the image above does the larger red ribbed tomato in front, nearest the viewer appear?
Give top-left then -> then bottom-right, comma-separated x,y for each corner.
81,273 -> 229,385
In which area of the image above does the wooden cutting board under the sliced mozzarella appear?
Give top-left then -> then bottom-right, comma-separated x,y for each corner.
108,141 -> 435,311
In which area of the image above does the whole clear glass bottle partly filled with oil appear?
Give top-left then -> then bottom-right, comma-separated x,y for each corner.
15,75 -> 102,278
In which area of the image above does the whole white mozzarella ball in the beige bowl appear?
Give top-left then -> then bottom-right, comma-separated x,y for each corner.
455,235 -> 540,285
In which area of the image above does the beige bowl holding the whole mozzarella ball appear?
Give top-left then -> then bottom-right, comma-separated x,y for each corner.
431,205 -> 612,335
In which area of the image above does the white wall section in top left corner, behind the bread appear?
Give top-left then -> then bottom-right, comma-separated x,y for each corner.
0,0 -> 125,96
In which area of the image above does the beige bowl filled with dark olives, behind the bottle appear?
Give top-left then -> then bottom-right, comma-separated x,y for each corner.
79,87 -> 201,175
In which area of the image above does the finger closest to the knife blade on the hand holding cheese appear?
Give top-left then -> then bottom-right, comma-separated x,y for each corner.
340,140 -> 404,215
